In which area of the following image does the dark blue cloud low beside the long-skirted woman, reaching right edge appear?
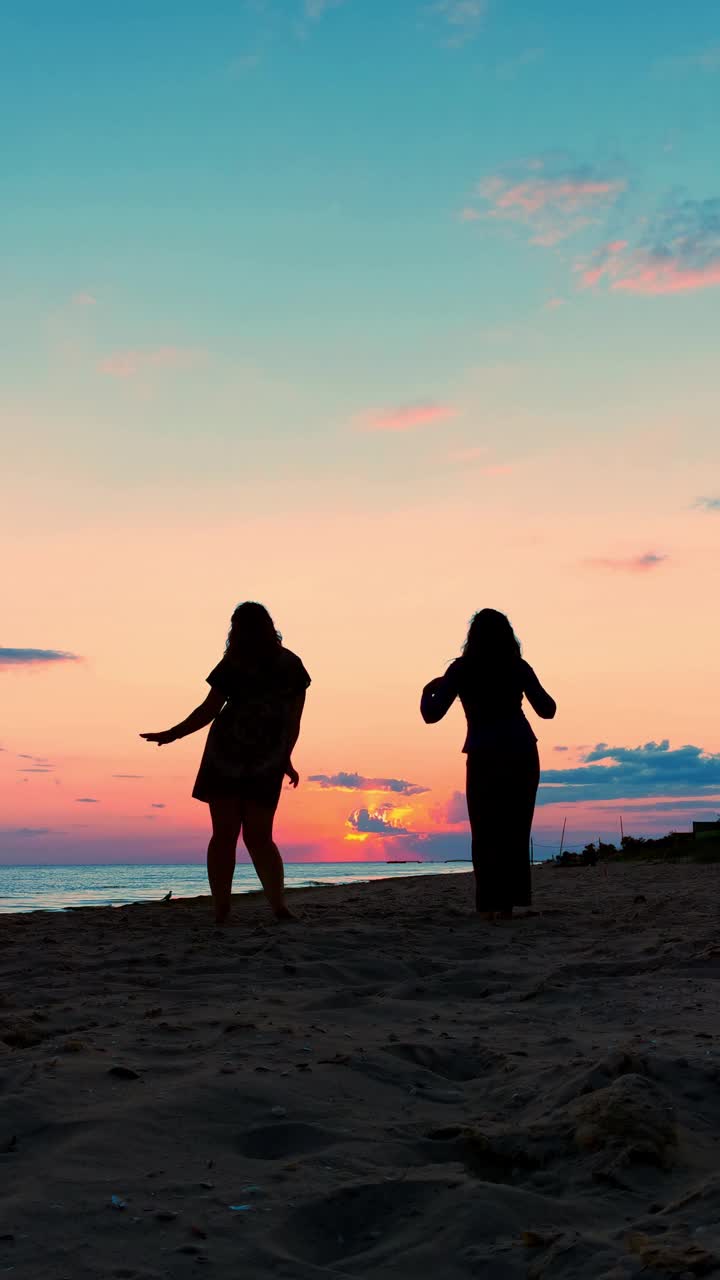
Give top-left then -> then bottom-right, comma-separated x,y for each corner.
538,739 -> 720,804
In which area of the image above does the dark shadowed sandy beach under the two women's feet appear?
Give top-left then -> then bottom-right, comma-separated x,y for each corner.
0,864 -> 720,1280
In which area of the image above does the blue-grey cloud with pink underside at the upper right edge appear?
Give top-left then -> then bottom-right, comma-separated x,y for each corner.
575,197 -> 720,296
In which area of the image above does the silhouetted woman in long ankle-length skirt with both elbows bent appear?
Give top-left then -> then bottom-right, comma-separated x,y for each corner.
420,609 -> 556,920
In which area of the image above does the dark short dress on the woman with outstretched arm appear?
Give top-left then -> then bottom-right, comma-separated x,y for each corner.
192,646 -> 310,808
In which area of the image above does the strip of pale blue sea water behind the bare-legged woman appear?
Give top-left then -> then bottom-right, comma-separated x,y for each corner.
0,863 -> 470,913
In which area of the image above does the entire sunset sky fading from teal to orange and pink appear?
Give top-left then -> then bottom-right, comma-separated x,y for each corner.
0,0 -> 720,863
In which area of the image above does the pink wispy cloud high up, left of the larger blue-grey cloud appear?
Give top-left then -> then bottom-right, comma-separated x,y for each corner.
460,157 -> 626,247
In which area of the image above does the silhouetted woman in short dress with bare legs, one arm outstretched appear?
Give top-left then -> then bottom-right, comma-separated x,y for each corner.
141,600 -> 310,924
